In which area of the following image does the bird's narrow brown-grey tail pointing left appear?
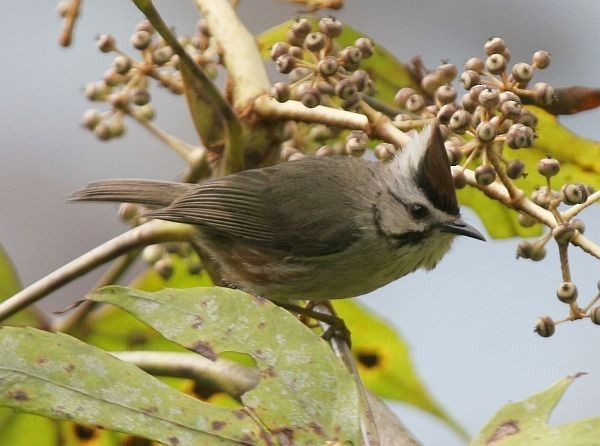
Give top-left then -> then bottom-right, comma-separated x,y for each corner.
69,180 -> 193,207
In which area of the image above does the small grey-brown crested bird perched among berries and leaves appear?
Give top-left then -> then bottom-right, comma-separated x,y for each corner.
70,126 -> 485,304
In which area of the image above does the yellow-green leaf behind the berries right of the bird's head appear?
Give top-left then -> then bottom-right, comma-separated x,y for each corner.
457,106 -> 600,238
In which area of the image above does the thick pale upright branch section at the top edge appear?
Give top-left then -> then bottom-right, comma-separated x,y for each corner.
196,0 -> 271,109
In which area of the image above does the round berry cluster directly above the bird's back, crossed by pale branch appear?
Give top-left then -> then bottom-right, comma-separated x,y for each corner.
271,17 -> 396,161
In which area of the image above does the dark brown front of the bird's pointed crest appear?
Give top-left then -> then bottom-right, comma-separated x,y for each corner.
415,125 -> 459,215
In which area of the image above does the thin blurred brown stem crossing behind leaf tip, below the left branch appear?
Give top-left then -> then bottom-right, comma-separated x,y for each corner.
52,249 -> 140,333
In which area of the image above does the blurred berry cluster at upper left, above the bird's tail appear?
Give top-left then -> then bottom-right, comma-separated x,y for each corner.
82,21 -> 221,140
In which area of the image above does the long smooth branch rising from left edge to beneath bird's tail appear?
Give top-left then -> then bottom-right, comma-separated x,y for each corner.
0,220 -> 196,321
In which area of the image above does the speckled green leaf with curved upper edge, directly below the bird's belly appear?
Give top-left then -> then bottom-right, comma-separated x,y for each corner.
91,286 -> 360,444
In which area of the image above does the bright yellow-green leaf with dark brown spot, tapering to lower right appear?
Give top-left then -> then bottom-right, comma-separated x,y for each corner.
333,299 -> 468,439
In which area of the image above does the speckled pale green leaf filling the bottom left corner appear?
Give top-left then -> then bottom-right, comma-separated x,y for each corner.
0,327 -> 262,446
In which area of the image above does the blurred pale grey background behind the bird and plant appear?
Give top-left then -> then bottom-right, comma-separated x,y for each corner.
0,0 -> 600,446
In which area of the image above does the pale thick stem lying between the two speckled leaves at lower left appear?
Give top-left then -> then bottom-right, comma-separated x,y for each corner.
111,351 -> 260,397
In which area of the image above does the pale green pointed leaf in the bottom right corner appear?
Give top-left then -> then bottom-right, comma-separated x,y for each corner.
470,374 -> 600,446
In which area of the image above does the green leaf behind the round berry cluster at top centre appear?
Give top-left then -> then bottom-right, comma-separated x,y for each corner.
256,17 -> 419,103
